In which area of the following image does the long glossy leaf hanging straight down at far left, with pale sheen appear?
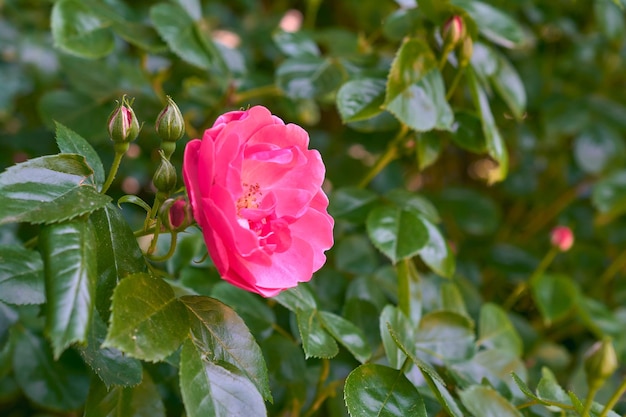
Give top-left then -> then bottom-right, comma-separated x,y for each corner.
39,219 -> 97,358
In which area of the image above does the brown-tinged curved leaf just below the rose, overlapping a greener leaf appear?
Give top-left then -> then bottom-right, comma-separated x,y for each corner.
181,296 -> 272,401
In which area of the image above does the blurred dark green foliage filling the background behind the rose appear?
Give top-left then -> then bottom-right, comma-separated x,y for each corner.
0,0 -> 626,417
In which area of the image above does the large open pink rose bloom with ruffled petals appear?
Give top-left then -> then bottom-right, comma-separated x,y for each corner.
183,106 -> 334,297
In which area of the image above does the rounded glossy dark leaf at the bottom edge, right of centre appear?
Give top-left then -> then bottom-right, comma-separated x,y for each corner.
344,364 -> 427,417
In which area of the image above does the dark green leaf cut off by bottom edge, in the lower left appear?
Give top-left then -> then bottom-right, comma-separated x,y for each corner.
83,368 -> 165,417
